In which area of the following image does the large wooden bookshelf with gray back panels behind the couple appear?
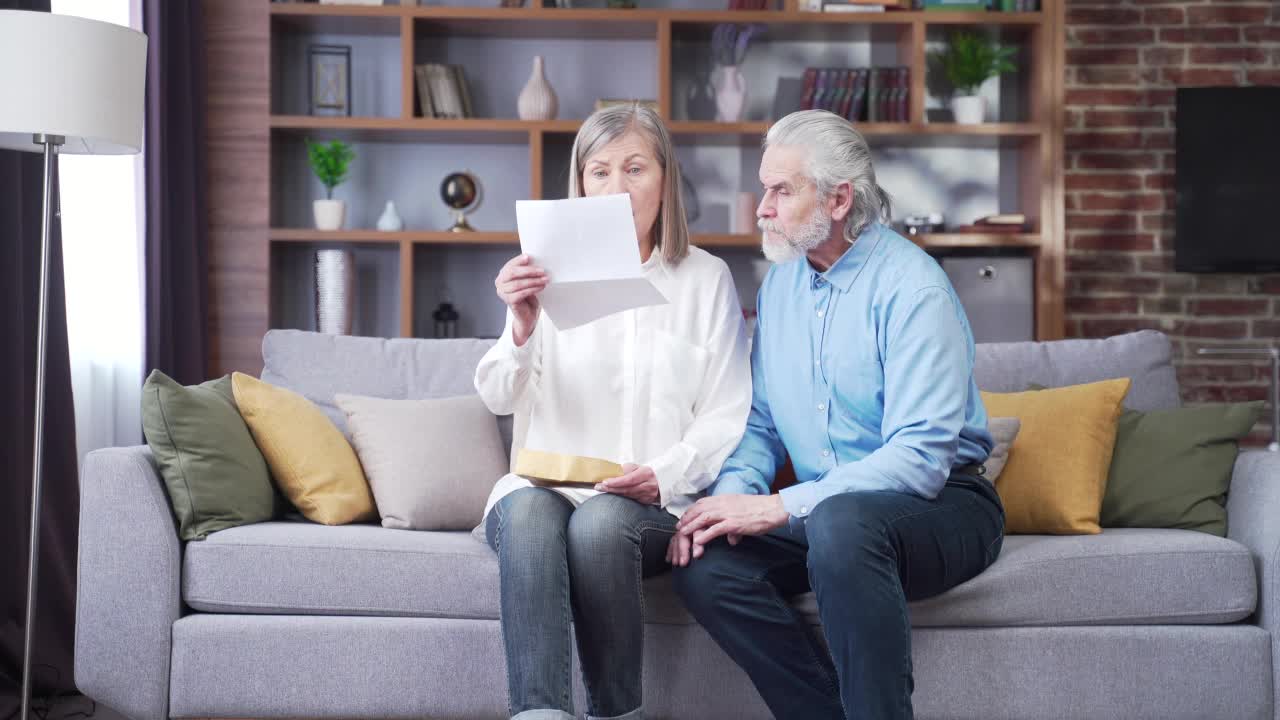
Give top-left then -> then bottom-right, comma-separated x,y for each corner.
205,0 -> 1064,370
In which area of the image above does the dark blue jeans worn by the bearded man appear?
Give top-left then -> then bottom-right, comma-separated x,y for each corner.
675,473 -> 1005,720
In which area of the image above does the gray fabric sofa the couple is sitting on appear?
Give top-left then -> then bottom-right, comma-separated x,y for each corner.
76,331 -> 1280,720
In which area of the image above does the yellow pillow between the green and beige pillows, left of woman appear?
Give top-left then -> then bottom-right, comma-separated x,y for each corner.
232,373 -> 378,525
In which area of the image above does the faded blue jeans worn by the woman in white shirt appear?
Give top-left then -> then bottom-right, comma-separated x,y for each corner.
485,487 -> 676,720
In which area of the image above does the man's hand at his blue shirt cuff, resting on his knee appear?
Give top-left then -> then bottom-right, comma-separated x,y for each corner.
667,495 -> 791,565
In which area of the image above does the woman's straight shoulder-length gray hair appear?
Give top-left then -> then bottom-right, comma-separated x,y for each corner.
568,102 -> 689,264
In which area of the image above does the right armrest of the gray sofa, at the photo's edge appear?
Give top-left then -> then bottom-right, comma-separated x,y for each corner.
1226,450 -> 1280,717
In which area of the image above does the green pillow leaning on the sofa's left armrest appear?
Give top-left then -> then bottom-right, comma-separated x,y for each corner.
142,370 -> 278,541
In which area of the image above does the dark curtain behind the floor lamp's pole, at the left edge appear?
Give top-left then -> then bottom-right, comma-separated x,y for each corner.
0,0 -> 79,717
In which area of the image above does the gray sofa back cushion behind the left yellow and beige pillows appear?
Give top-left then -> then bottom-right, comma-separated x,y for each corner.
262,331 -> 511,451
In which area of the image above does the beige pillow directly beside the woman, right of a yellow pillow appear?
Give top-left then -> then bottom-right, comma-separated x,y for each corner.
334,395 -> 507,530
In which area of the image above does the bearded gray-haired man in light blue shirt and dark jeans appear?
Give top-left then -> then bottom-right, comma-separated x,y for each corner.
668,110 -> 1005,720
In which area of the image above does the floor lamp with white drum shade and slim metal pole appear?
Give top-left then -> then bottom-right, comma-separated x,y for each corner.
0,10 -> 147,720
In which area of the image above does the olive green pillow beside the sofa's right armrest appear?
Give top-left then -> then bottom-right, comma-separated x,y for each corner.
1100,402 -> 1263,537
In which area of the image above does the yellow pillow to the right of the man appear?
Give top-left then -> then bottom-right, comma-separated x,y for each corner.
982,378 -> 1129,536
